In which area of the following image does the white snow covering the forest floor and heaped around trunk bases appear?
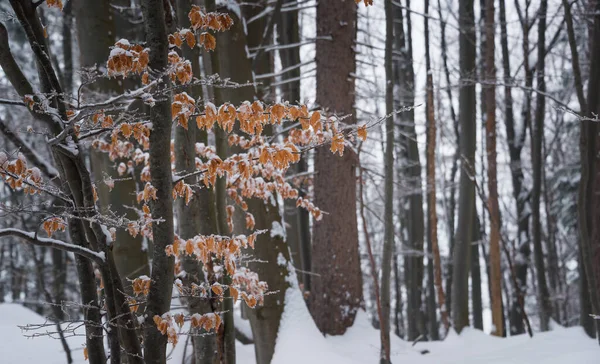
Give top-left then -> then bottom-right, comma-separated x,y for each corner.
0,296 -> 600,364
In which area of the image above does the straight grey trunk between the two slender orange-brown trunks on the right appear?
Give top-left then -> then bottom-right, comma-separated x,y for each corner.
452,0 -> 477,333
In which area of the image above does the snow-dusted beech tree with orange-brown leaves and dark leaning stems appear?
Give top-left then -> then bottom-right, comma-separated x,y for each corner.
0,0 -> 366,363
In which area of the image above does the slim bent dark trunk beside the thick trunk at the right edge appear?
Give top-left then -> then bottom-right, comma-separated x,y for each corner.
562,0 -> 596,337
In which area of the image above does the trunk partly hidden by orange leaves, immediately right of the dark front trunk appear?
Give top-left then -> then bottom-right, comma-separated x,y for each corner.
175,0 -> 217,364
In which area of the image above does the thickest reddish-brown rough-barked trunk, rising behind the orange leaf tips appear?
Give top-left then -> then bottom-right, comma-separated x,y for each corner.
310,0 -> 362,335
